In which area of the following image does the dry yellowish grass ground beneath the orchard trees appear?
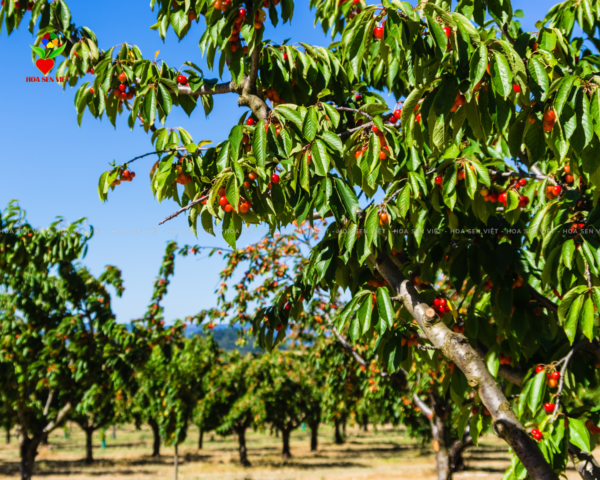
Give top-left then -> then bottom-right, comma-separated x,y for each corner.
0,424 -> 598,480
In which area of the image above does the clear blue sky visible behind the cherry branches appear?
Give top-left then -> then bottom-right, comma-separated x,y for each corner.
0,0 -> 556,322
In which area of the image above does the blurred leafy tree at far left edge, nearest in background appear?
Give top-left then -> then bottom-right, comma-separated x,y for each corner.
0,203 -> 127,479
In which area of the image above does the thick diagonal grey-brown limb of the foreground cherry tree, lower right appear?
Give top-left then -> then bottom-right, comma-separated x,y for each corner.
378,254 -> 558,480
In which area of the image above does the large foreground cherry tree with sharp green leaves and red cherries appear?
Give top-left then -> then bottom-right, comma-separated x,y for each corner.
5,0 -> 600,480
